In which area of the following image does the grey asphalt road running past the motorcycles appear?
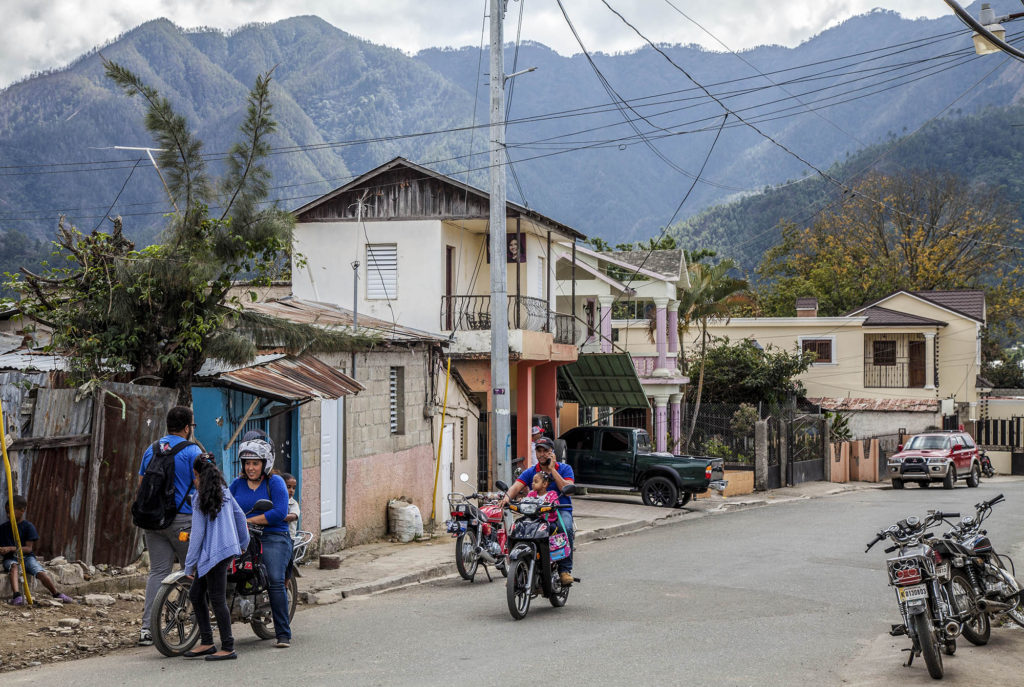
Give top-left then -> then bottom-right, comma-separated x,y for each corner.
3,479 -> 1024,687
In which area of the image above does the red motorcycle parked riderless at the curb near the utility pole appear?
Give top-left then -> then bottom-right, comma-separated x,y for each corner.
444,472 -> 512,582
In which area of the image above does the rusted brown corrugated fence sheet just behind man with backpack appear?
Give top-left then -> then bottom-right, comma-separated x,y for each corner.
93,383 -> 177,566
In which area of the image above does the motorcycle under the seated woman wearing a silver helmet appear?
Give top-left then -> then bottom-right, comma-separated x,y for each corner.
150,499 -> 303,657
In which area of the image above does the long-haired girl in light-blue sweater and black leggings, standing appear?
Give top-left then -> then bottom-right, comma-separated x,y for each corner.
184,454 -> 249,660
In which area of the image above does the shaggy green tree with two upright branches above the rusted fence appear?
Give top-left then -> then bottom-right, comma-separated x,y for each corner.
10,61 -> 367,401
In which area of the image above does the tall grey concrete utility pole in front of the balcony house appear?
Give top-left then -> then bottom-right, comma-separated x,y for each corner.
488,0 -> 512,485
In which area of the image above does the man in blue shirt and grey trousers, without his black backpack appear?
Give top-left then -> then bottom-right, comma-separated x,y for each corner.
138,405 -> 203,646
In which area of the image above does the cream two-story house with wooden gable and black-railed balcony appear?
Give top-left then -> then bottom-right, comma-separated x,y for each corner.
292,158 -> 584,482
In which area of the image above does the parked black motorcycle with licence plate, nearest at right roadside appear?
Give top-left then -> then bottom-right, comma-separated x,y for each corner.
864,511 -> 974,680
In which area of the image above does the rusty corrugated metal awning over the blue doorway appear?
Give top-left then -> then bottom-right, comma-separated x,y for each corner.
204,355 -> 366,401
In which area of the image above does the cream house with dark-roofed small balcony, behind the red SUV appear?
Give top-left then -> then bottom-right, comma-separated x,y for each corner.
684,290 -> 985,436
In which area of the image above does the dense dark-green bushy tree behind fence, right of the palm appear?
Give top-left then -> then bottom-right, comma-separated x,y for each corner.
691,338 -> 814,409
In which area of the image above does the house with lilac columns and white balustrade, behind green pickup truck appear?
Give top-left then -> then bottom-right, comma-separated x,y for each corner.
557,244 -> 689,450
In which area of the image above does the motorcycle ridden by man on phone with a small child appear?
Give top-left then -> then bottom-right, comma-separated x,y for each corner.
496,482 -> 580,620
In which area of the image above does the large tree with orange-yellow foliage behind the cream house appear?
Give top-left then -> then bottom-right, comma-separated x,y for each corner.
758,173 -> 1024,341
